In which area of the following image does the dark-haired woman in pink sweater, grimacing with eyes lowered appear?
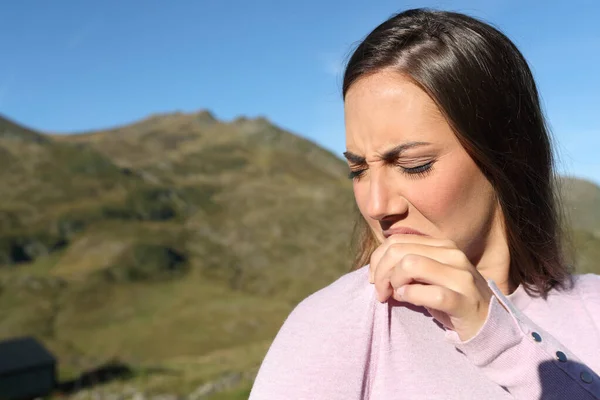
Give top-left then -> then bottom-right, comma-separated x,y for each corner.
250,9 -> 600,400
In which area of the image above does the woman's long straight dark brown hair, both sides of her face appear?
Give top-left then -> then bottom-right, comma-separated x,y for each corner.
343,9 -> 571,297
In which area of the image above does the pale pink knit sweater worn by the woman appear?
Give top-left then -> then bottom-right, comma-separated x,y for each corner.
250,267 -> 600,400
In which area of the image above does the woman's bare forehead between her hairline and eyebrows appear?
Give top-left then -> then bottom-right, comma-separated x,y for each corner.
344,71 -> 455,150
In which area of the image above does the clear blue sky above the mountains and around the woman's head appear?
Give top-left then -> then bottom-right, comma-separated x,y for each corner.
0,0 -> 600,183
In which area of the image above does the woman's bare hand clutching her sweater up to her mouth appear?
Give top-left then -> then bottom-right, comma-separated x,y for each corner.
369,235 -> 493,341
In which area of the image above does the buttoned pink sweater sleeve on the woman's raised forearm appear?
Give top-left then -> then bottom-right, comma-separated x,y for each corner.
446,280 -> 600,400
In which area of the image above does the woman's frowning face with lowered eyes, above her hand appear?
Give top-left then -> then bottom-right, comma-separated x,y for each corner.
344,71 -> 501,265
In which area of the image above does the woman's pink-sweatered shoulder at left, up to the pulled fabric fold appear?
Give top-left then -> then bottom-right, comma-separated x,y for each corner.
251,267 -> 376,392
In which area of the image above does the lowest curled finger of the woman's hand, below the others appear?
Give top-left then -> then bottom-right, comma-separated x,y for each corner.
393,283 -> 466,318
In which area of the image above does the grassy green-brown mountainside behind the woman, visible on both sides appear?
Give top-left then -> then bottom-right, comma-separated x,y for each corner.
0,110 -> 600,399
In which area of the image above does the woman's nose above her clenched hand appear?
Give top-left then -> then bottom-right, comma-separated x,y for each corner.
367,167 -> 408,221
